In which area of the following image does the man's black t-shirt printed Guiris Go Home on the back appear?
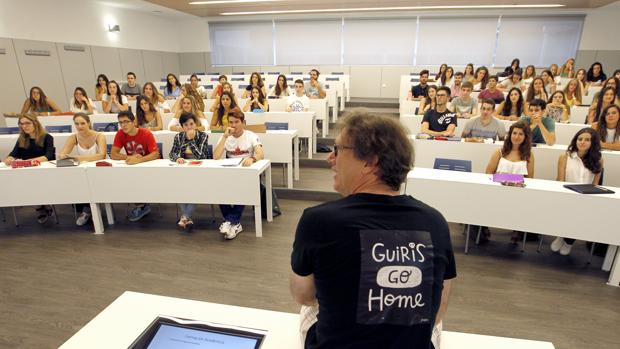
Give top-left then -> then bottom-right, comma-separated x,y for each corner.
291,194 -> 456,349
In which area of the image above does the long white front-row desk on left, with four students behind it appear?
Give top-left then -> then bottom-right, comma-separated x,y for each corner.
82,159 -> 273,237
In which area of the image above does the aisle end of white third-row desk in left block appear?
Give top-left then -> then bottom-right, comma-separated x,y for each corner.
244,112 -> 316,159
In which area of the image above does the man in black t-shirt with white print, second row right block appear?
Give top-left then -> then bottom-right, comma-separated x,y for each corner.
421,86 -> 457,137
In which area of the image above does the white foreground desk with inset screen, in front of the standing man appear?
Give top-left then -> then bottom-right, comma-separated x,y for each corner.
60,291 -> 554,349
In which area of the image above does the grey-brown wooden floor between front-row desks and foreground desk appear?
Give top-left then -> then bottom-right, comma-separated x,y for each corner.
0,200 -> 620,349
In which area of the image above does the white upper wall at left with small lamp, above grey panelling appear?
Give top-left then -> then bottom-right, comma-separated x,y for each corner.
0,0 -> 209,52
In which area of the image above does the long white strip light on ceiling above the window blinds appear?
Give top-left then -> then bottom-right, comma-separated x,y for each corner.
220,4 -> 565,16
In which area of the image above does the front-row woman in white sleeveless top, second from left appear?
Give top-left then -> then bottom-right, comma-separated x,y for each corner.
59,113 -> 107,227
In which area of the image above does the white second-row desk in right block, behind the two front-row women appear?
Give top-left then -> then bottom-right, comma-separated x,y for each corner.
411,136 -> 620,187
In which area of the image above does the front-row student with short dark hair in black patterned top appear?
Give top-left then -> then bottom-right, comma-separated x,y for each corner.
169,113 -> 211,230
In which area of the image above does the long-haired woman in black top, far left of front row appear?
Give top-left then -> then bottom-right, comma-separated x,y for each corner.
4,114 -> 56,224
